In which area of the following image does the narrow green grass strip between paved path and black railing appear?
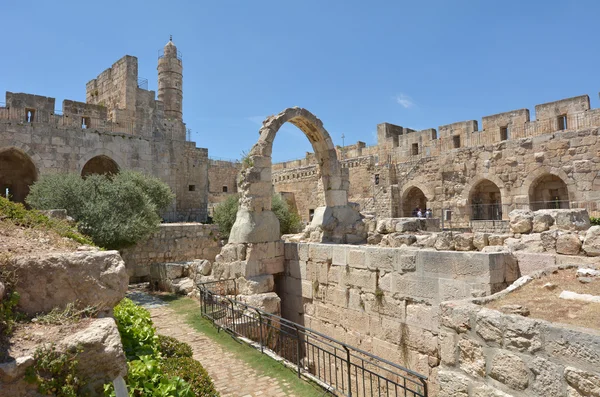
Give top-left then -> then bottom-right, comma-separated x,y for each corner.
162,297 -> 329,397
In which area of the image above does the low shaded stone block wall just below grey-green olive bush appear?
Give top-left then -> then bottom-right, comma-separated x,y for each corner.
121,223 -> 221,283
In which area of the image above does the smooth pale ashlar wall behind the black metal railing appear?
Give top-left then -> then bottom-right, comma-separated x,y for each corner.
276,243 -> 518,388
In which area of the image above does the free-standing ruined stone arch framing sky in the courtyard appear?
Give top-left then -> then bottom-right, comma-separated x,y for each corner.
229,107 -> 360,243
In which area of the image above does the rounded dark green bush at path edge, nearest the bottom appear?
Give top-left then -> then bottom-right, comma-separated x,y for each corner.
162,357 -> 219,397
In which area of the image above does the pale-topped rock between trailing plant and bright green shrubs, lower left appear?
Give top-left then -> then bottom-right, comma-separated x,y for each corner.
61,317 -> 127,393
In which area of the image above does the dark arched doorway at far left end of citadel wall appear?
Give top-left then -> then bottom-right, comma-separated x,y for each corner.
0,148 -> 37,203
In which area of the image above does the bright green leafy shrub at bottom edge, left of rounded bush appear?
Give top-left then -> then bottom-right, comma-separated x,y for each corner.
104,356 -> 195,397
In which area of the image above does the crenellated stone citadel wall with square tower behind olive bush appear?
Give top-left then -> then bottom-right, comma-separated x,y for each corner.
0,45 -> 208,221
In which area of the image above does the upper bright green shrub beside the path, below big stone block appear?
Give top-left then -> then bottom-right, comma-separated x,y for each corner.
114,298 -> 159,360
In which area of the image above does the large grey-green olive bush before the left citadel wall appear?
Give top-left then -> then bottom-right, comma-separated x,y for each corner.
27,171 -> 174,249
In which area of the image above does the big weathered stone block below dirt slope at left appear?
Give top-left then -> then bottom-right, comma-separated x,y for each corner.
12,251 -> 128,314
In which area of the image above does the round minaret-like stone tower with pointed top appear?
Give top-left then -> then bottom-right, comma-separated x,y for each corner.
158,37 -> 183,121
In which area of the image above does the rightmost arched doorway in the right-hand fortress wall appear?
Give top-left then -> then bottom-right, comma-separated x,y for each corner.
529,174 -> 569,211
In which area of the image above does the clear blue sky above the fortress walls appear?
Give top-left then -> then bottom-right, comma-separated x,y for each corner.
0,0 -> 600,161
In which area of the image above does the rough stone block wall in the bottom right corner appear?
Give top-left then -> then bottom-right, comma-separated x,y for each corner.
438,302 -> 600,397
